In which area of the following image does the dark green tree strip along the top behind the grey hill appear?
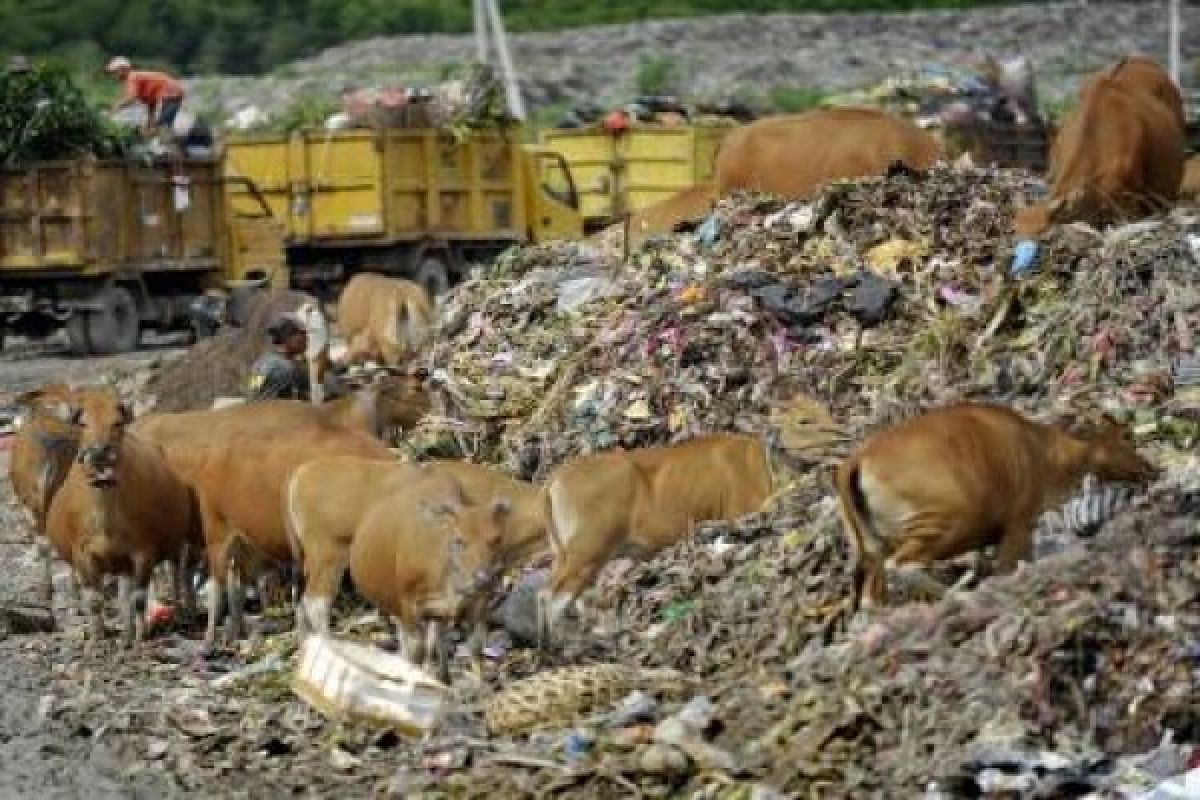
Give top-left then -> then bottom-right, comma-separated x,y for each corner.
0,0 -> 1032,74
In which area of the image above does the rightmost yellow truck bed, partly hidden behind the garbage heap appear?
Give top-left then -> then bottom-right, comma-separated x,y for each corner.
541,121 -> 737,233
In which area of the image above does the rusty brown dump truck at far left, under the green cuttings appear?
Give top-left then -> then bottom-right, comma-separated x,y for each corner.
0,160 -> 281,353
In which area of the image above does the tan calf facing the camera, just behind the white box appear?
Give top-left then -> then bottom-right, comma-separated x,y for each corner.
349,473 -> 506,681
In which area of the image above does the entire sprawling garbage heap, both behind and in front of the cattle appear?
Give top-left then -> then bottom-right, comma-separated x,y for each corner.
11,167 -> 1200,800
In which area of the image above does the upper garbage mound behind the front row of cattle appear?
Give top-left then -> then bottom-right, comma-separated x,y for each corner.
418,160 -> 1200,476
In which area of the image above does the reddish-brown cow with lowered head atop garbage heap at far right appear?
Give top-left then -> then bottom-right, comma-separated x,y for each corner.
1014,59 -> 1184,237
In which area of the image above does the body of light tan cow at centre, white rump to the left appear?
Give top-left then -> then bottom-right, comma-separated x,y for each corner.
538,434 -> 772,642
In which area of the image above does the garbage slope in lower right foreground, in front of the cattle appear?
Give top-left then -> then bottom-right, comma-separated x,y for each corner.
381,459 -> 1200,799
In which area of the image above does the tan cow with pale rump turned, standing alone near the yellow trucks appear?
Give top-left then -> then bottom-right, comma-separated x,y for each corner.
337,272 -> 436,367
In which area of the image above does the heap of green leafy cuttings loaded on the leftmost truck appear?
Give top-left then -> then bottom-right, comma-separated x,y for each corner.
0,62 -> 137,167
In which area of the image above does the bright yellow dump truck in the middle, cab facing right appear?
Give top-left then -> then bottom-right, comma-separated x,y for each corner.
226,128 -> 582,294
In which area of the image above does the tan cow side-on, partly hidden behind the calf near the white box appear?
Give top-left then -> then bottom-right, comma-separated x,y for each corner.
284,456 -> 535,631
